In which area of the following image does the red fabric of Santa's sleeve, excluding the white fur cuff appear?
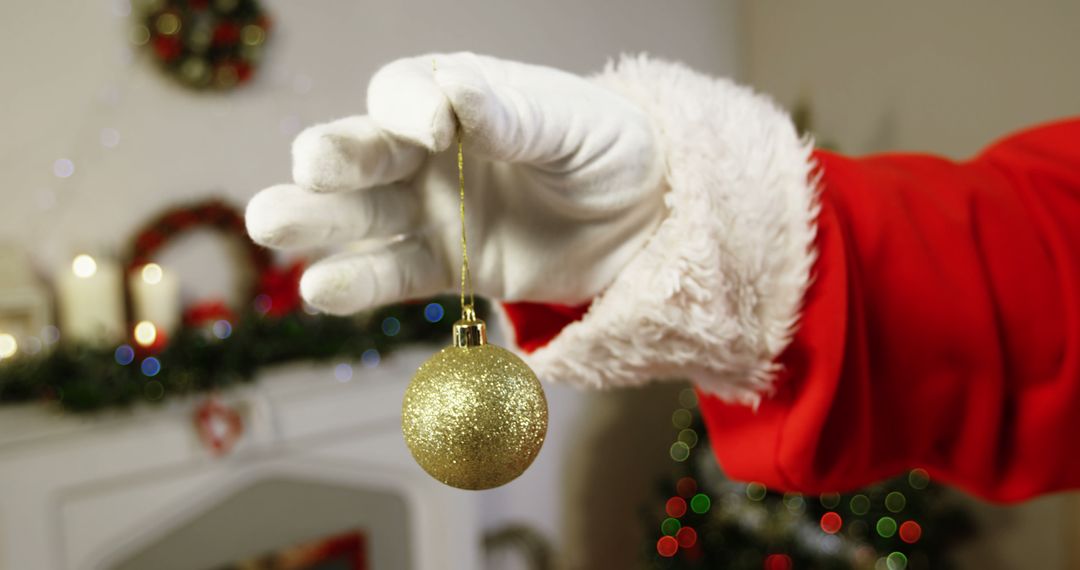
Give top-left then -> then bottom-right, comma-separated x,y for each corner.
511,120 -> 1080,501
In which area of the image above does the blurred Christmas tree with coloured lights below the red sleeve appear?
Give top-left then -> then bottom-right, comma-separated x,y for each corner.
646,389 -> 974,570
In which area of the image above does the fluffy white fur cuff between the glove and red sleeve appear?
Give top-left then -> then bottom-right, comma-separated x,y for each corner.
529,56 -> 816,405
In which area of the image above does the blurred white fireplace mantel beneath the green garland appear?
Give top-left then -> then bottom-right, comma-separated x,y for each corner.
0,350 -> 481,570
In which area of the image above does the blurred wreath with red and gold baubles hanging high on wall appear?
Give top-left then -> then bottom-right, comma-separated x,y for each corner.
133,0 -> 271,91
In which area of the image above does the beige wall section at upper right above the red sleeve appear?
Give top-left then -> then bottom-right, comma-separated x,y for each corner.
742,0 -> 1080,157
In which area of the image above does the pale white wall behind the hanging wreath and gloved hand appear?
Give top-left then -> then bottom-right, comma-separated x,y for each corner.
0,0 -> 737,276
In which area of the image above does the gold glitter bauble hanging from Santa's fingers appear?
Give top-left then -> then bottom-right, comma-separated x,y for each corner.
402,321 -> 548,490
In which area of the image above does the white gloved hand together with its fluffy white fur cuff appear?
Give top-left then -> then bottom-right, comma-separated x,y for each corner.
247,54 -> 816,404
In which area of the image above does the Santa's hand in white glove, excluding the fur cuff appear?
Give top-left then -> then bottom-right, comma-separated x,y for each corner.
247,53 -> 665,314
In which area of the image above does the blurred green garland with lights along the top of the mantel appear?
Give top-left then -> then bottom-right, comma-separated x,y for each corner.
0,297 -> 486,413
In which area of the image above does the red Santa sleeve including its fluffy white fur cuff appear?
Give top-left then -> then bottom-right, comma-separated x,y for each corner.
496,59 -> 1080,501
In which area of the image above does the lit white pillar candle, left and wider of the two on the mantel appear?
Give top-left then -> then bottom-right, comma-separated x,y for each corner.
56,255 -> 125,347
